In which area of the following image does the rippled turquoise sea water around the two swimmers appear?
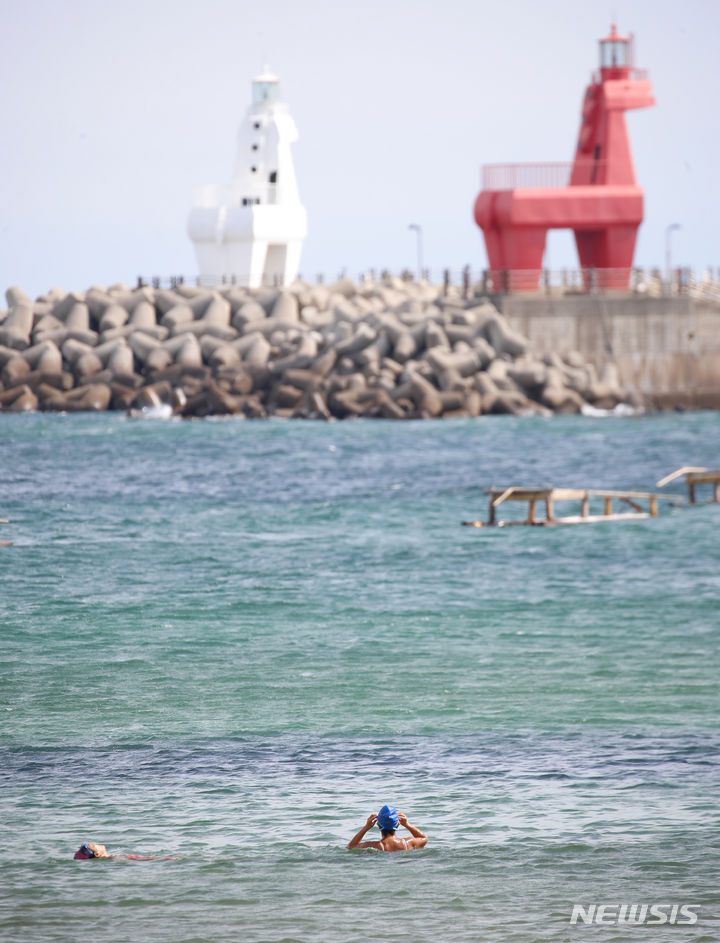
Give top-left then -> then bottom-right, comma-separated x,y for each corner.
0,413 -> 720,943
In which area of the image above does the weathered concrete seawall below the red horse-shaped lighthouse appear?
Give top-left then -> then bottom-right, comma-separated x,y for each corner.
492,294 -> 720,408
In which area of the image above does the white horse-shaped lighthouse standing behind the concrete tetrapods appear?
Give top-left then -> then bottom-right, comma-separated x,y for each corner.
188,66 -> 307,288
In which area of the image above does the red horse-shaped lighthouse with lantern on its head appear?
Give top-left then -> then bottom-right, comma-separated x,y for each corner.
475,24 -> 655,290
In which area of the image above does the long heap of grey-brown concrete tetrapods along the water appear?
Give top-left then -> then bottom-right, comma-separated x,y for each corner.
0,278 -> 628,419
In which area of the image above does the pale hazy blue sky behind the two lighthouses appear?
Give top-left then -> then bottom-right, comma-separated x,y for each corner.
0,0 -> 720,303
